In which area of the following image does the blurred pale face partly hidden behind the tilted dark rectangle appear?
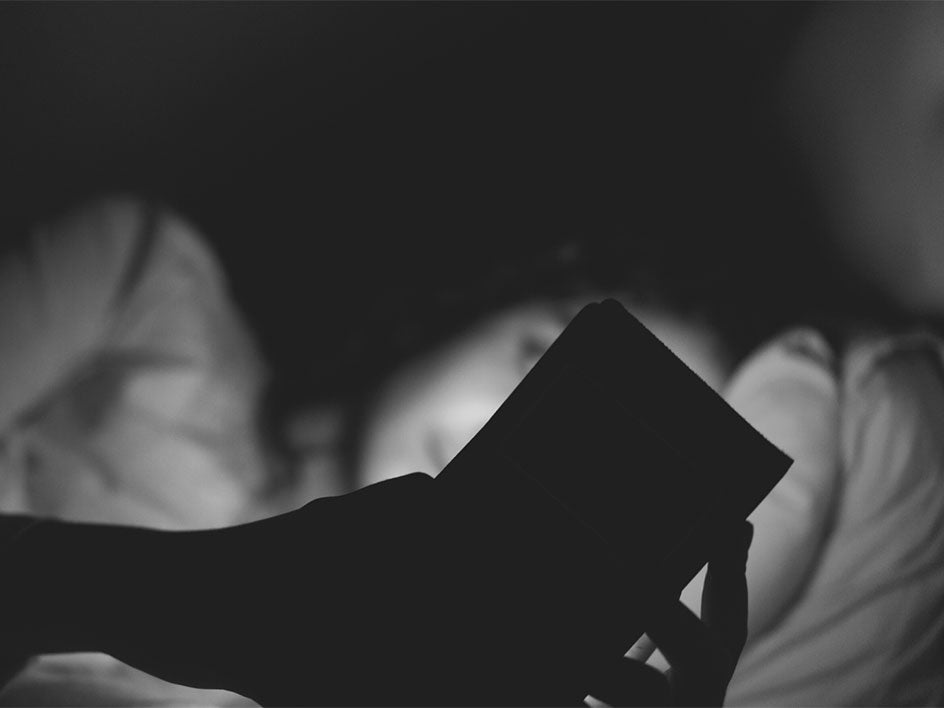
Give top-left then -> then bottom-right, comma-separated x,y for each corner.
360,301 -> 726,484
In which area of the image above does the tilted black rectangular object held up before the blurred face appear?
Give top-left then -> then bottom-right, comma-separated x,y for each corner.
436,300 -> 792,703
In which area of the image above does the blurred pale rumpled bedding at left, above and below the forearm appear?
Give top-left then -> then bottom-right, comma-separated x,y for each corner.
0,199 -> 266,705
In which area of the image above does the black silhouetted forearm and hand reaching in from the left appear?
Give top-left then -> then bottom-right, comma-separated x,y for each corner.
31,474 -> 745,705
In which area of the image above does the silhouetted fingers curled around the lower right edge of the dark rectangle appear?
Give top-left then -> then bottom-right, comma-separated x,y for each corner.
587,522 -> 753,706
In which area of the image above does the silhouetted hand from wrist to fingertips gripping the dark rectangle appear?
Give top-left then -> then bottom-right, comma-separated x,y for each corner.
216,474 -> 751,705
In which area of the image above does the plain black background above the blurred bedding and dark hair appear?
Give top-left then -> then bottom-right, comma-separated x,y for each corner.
0,2 -> 812,398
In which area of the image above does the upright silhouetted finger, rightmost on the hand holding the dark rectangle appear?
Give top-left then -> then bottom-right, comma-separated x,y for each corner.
701,522 -> 754,660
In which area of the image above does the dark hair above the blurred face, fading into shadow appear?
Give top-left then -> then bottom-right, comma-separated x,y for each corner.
338,177 -> 897,398
